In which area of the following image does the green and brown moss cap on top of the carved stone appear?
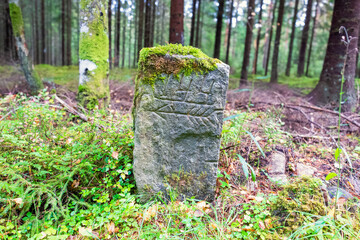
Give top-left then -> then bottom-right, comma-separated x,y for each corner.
137,44 -> 221,86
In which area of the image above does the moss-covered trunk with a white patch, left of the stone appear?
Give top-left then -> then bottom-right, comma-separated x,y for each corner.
78,0 -> 110,109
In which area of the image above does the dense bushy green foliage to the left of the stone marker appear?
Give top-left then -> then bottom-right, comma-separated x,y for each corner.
0,92 -> 134,237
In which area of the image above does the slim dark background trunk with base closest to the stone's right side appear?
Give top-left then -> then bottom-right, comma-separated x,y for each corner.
240,0 -> 255,85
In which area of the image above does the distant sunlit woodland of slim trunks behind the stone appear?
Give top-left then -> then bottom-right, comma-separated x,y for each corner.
0,0 -> 360,76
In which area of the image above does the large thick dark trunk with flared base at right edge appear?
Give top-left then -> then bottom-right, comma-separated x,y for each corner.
309,0 -> 360,111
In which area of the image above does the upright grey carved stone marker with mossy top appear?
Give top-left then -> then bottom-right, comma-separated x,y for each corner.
133,44 -> 229,201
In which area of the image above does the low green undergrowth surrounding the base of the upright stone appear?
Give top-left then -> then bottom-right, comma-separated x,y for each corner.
0,86 -> 360,239
